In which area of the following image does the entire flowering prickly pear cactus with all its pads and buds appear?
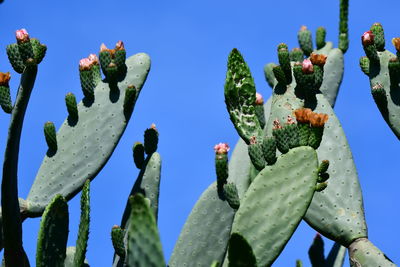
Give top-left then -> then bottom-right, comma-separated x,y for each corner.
0,0 -> 400,267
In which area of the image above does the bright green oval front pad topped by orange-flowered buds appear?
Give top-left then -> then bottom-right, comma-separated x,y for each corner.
224,147 -> 318,266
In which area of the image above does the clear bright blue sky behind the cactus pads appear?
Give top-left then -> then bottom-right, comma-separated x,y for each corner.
0,0 -> 400,267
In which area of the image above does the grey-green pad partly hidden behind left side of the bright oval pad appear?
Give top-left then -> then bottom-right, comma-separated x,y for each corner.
169,182 -> 234,267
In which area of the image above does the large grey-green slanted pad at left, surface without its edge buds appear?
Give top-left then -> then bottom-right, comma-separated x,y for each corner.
27,54 -> 150,216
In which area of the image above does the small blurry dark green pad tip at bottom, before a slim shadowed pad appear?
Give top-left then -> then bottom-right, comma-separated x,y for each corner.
126,194 -> 165,267
